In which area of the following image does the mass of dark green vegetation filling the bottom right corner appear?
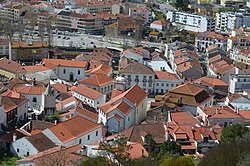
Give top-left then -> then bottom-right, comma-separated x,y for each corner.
198,124 -> 250,166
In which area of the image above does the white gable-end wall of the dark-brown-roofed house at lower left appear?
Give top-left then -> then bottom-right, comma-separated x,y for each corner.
10,137 -> 39,158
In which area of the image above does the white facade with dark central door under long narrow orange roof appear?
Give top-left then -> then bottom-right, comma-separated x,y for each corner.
56,66 -> 85,81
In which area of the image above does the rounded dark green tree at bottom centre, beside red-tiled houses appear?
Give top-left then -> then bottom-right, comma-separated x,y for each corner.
158,141 -> 182,159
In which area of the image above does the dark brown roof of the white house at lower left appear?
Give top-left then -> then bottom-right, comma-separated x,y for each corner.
26,132 -> 56,152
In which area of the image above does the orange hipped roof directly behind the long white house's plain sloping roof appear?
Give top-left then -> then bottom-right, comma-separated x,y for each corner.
78,74 -> 114,86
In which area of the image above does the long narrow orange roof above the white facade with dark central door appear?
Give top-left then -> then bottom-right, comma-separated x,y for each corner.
43,58 -> 88,69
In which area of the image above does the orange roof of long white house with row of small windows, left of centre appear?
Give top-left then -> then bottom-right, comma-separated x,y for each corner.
72,84 -> 103,99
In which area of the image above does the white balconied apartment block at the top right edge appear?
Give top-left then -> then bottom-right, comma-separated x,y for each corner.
216,12 -> 250,34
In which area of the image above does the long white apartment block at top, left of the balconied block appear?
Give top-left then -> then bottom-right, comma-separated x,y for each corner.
167,11 -> 215,32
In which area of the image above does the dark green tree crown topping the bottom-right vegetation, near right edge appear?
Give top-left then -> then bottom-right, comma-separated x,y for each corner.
221,124 -> 248,143
